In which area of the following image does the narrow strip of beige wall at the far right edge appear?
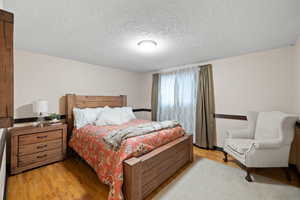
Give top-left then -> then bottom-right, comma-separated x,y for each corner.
294,36 -> 300,115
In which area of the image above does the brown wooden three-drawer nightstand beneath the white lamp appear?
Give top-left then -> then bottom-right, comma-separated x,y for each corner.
10,124 -> 67,174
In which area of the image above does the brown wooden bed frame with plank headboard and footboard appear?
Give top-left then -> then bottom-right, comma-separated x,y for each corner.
66,94 -> 193,200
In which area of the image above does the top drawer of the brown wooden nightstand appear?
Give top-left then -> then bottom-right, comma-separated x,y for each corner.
19,130 -> 62,145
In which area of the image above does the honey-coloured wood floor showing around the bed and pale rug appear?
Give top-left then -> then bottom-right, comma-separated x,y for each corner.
7,147 -> 300,200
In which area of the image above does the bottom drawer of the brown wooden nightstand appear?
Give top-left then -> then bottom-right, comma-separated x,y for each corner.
18,148 -> 63,167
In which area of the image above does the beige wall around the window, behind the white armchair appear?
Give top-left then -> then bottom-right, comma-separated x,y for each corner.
144,47 -> 294,146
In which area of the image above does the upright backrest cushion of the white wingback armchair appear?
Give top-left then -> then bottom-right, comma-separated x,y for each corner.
255,111 -> 282,140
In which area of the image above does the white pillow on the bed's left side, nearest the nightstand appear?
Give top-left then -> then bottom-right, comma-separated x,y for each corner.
73,107 -> 104,128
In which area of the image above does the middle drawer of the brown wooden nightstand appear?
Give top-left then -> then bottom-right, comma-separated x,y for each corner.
18,139 -> 62,156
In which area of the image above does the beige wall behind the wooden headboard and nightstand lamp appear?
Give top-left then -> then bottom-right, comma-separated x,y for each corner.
14,50 -> 148,118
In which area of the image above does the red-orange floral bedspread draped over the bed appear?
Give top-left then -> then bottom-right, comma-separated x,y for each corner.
69,119 -> 184,200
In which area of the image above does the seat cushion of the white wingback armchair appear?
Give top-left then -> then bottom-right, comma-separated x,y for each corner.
226,139 -> 254,155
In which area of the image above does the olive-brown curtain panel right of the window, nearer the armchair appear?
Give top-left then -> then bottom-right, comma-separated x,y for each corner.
195,65 -> 216,149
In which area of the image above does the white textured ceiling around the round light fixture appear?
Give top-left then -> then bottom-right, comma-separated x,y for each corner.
4,0 -> 300,71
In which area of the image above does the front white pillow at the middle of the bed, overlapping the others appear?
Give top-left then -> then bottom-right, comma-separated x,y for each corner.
95,106 -> 136,126
